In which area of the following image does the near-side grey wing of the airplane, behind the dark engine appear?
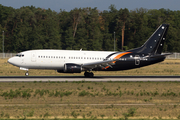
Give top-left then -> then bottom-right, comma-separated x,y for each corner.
82,59 -> 119,70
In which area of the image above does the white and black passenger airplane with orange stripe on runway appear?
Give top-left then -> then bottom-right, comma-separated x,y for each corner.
8,24 -> 171,77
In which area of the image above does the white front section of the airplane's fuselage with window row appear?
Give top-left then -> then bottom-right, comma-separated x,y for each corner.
8,50 -> 114,70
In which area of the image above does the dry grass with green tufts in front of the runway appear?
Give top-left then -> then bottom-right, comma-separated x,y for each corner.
0,81 -> 180,119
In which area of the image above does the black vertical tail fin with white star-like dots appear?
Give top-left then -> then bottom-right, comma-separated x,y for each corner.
137,24 -> 169,55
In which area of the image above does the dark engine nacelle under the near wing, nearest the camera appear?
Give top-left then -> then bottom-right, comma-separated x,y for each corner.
64,63 -> 82,73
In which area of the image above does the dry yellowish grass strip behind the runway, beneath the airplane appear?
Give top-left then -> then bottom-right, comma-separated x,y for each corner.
0,59 -> 180,76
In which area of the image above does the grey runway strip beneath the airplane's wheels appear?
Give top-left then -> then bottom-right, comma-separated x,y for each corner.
0,76 -> 180,82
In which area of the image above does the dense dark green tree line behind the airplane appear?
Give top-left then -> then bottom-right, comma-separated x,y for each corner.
0,4 -> 180,52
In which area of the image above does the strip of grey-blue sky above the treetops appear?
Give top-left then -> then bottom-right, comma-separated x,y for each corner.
0,0 -> 180,12
